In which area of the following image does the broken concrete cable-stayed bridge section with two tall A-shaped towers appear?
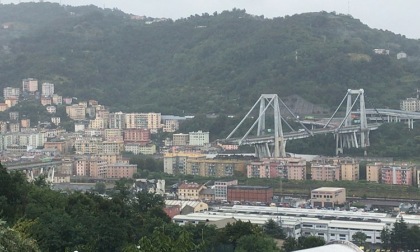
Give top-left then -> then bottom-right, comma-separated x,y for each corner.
222,89 -> 380,158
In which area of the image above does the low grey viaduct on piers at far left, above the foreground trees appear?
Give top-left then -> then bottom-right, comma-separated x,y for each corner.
4,160 -> 63,183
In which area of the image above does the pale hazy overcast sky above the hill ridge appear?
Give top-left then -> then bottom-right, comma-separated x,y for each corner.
0,0 -> 420,39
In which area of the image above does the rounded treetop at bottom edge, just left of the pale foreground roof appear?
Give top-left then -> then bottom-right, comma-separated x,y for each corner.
235,234 -> 280,252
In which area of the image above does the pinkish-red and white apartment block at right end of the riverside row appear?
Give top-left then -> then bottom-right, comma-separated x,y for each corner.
381,166 -> 413,185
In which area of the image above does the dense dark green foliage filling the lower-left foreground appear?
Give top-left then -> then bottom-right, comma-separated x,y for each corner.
0,165 -> 292,252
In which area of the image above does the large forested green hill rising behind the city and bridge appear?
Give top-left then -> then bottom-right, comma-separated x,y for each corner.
0,3 -> 420,114
